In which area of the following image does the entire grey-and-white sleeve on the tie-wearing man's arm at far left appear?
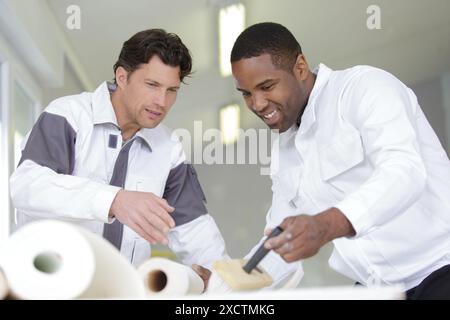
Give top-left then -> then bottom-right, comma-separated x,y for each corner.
10,105 -> 120,222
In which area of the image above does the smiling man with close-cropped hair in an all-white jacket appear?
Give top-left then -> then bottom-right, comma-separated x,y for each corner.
227,23 -> 450,299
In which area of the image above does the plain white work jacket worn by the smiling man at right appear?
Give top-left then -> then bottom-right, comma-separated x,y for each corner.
267,64 -> 450,289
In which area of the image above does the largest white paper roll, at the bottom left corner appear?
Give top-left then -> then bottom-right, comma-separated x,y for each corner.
0,220 -> 145,299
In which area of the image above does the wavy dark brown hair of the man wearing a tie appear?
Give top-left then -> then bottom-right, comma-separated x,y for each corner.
113,29 -> 192,81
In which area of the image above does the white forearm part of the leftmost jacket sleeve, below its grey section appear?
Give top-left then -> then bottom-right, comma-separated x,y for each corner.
10,160 -> 119,222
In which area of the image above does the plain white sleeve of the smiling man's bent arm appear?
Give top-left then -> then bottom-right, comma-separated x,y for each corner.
335,70 -> 427,237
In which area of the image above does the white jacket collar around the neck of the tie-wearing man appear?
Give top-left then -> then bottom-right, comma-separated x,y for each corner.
92,81 -> 152,150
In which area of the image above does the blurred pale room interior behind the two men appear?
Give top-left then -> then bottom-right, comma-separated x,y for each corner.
0,0 -> 450,286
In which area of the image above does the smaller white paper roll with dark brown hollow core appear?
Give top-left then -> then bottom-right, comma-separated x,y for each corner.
138,258 -> 204,297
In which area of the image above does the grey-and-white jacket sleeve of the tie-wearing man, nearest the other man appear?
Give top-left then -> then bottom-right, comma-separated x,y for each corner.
163,143 -> 228,269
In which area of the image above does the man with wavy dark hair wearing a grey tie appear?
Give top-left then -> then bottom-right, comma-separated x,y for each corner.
10,29 -> 226,276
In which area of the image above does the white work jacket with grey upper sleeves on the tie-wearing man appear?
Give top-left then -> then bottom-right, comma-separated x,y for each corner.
10,82 -> 226,267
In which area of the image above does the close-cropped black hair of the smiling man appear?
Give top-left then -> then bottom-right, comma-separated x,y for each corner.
230,22 -> 302,72
